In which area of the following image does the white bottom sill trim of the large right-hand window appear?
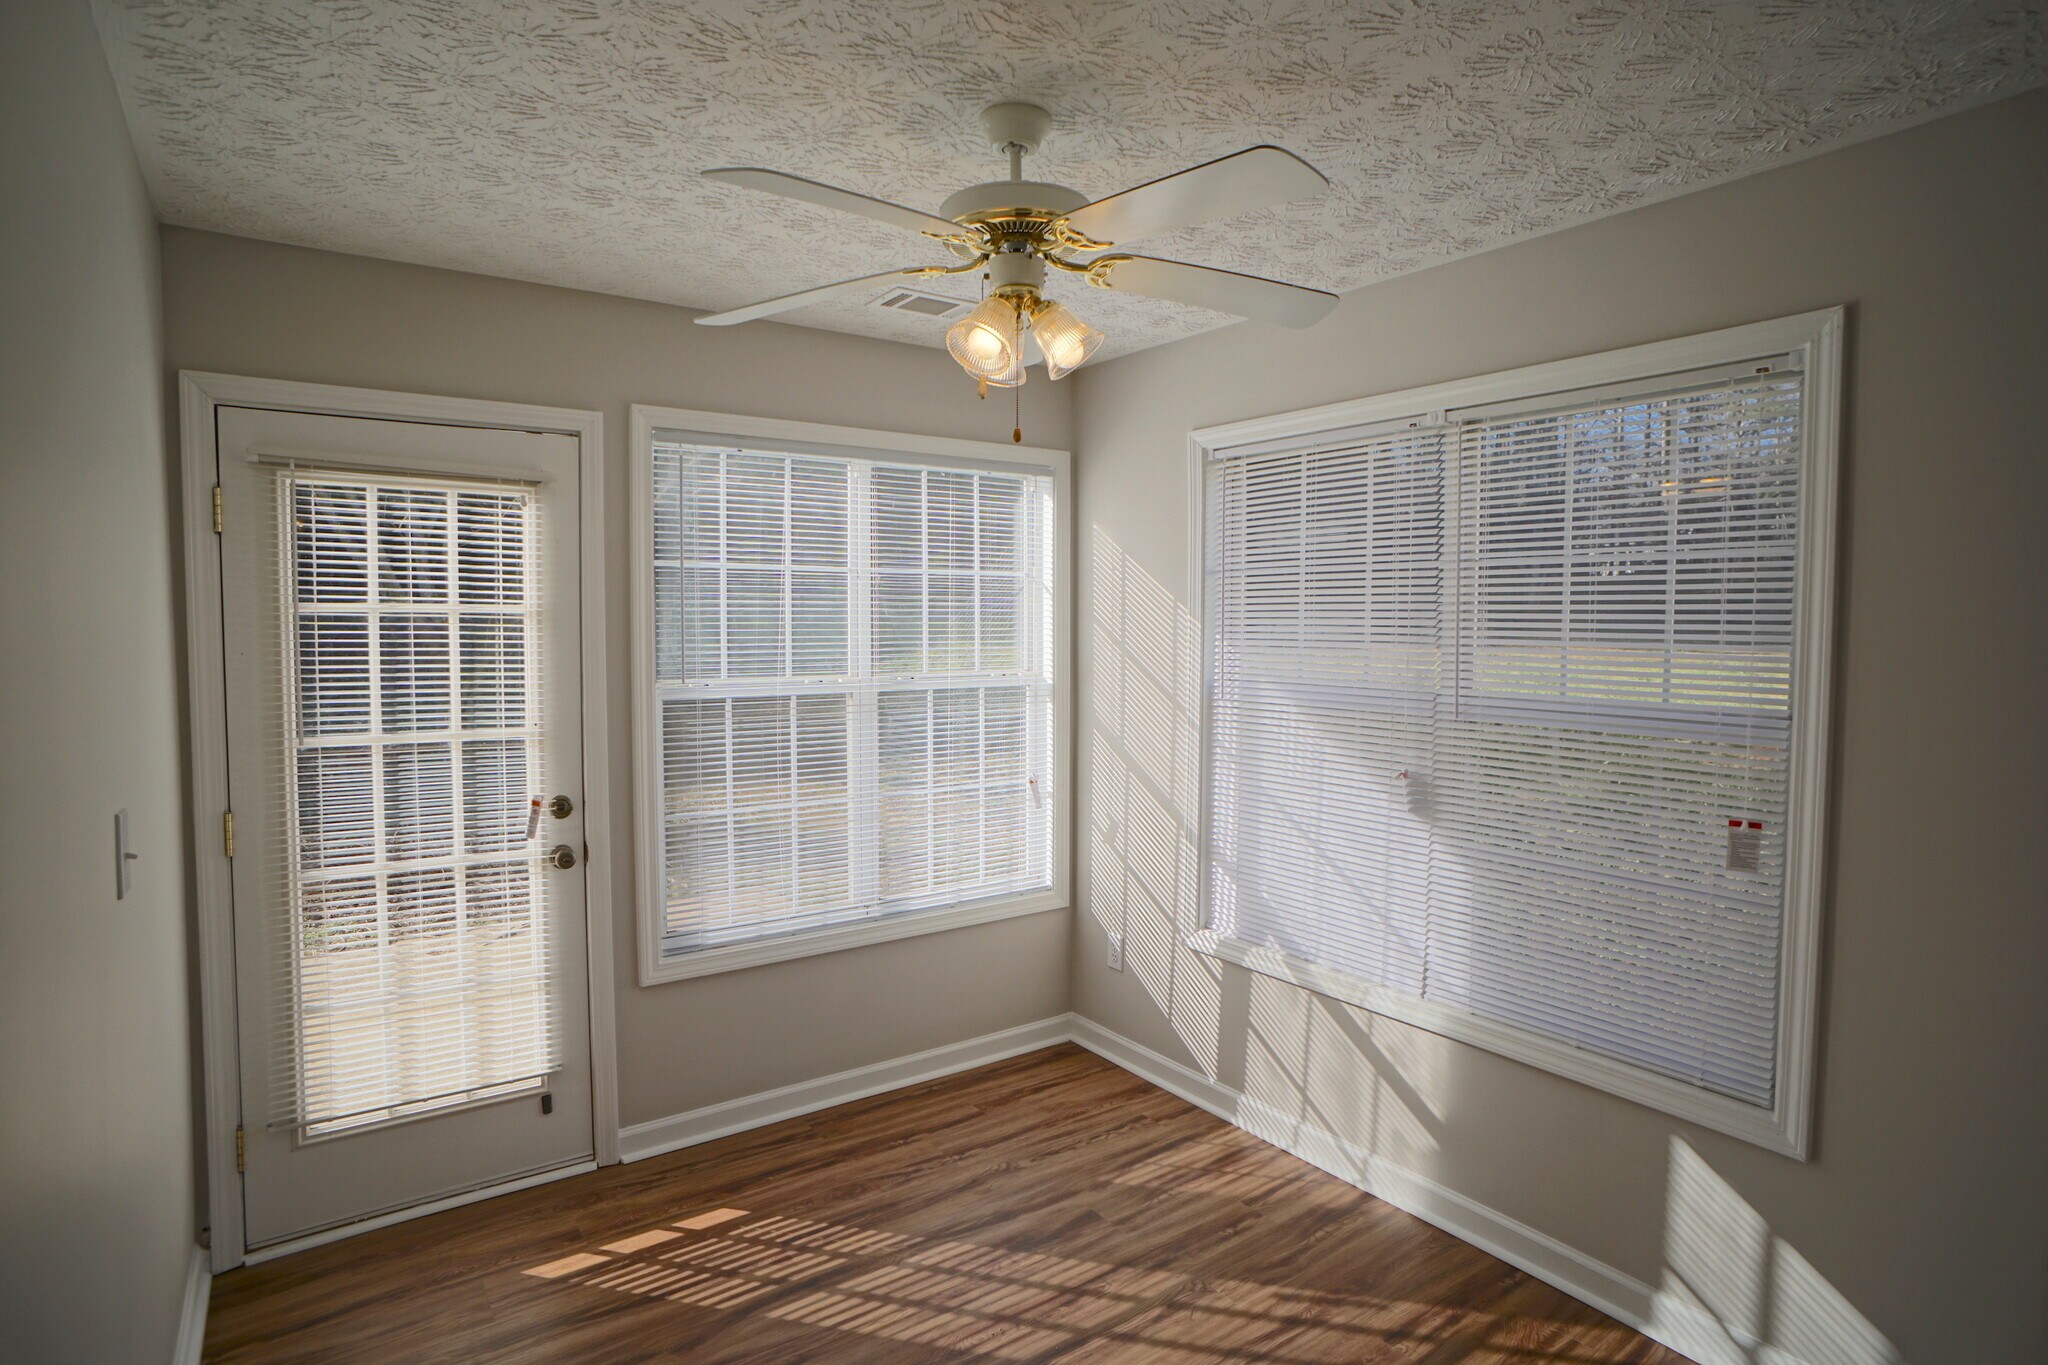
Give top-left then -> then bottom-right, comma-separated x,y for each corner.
1188,929 -> 1806,1160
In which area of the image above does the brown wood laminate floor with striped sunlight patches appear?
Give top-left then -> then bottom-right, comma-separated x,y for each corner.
205,1046 -> 1683,1365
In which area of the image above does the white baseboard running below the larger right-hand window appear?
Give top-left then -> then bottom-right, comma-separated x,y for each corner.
1071,1015 -> 1804,1365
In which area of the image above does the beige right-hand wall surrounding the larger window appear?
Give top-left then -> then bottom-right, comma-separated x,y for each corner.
1073,92 -> 2048,1365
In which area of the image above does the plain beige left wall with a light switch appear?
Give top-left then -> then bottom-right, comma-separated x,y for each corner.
0,0 -> 195,1365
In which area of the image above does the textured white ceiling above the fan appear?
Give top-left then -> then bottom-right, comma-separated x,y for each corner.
98,0 -> 2048,354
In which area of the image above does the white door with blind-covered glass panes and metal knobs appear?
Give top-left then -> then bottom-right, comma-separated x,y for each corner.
217,407 -> 592,1248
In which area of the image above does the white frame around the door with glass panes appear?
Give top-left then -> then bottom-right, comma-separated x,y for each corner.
178,370 -> 618,1273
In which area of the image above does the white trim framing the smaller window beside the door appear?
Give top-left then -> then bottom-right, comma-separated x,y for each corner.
629,403 -> 1073,986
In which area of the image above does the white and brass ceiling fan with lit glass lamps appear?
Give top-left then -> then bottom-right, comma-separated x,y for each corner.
696,104 -> 1337,391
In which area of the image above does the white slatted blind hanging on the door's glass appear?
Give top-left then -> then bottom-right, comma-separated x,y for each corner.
272,469 -> 555,1136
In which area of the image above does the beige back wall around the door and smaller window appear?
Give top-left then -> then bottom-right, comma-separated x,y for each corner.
164,227 -> 1071,1124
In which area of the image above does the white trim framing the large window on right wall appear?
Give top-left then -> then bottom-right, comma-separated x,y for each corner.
1188,307 -> 1843,1160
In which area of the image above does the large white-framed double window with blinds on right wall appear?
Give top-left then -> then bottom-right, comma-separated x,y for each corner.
1198,315 -> 1839,1152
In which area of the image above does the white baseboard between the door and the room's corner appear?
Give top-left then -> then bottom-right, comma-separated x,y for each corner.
618,1015 -> 1073,1160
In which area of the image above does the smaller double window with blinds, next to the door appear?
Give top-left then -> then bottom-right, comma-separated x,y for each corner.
637,411 -> 1063,980
